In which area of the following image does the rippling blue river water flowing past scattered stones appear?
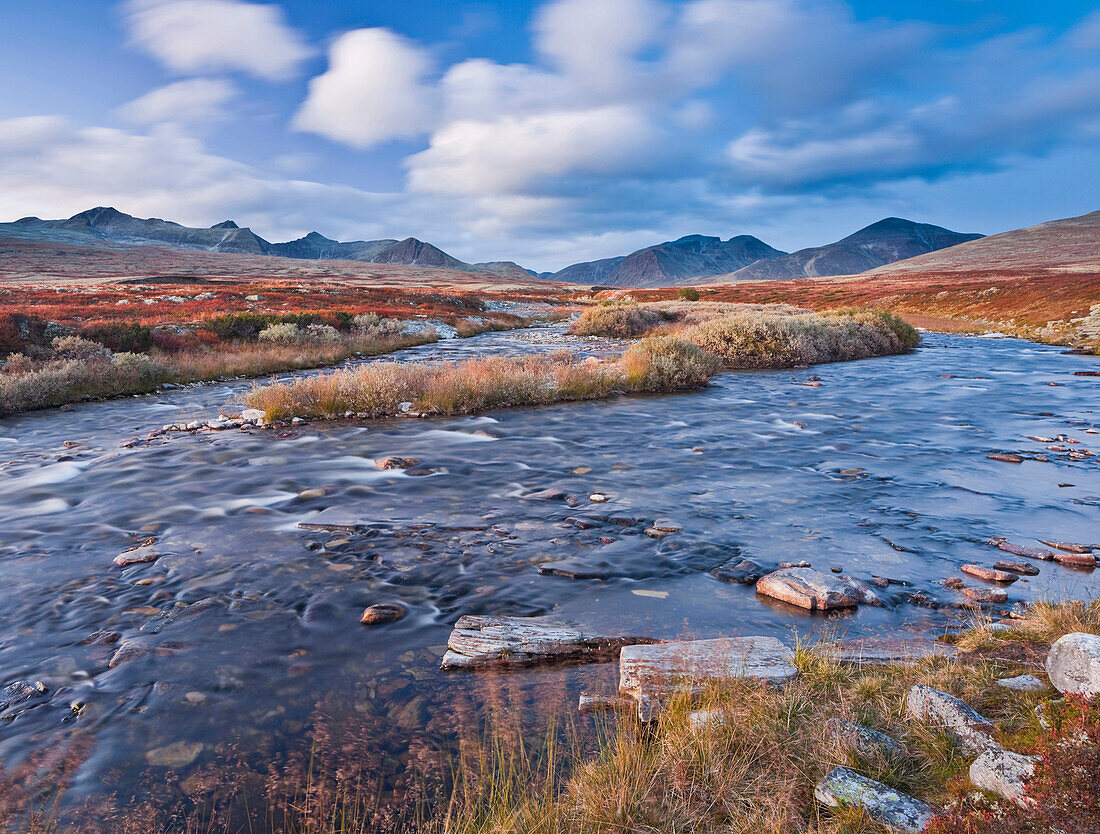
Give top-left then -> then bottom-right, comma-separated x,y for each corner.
0,328 -> 1100,822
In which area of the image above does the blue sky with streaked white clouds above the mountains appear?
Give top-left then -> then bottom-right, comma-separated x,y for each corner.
0,0 -> 1100,270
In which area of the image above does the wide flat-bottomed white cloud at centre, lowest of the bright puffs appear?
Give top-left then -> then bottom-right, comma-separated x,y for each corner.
407,106 -> 656,194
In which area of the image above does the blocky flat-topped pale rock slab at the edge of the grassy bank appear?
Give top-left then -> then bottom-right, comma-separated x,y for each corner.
619,637 -> 799,721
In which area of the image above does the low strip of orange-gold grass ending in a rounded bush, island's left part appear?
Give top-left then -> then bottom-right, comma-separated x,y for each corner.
245,339 -> 717,420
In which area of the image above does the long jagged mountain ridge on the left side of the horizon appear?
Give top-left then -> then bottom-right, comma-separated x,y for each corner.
0,207 -> 503,273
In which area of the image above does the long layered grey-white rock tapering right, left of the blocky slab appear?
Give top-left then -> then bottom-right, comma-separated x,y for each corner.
442,616 -> 652,669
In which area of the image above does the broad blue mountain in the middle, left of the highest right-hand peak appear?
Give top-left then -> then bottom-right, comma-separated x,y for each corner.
547,234 -> 784,287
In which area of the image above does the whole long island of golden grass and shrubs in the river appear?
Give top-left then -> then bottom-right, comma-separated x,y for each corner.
244,305 -> 920,420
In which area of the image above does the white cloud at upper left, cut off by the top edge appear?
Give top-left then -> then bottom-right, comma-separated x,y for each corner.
124,0 -> 312,80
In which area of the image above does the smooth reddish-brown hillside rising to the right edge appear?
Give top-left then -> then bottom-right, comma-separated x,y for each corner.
868,211 -> 1100,276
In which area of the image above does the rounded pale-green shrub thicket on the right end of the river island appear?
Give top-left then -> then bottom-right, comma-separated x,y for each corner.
682,311 -> 920,367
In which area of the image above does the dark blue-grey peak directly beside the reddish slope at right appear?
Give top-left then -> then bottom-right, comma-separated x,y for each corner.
714,217 -> 982,283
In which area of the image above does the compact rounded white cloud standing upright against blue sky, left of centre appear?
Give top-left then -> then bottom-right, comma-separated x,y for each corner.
294,29 -> 437,147
